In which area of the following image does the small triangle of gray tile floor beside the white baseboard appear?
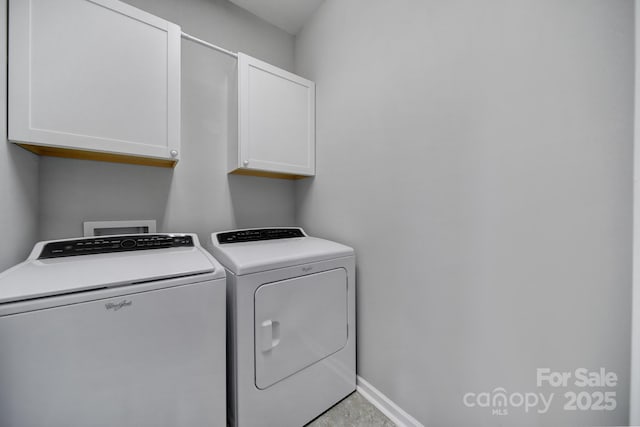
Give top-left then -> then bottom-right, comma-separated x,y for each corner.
306,391 -> 395,427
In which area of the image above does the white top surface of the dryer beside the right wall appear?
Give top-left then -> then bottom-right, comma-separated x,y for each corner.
211,229 -> 354,275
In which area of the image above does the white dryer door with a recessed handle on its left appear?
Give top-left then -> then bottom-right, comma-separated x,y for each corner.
255,268 -> 347,389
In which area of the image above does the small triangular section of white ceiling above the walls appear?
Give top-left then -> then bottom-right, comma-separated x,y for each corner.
229,0 -> 324,35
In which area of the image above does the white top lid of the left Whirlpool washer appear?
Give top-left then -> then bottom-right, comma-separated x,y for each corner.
0,235 -> 224,304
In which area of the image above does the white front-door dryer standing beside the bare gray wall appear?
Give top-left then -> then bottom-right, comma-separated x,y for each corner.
212,228 -> 356,427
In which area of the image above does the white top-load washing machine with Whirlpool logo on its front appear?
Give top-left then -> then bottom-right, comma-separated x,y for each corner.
0,234 -> 226,427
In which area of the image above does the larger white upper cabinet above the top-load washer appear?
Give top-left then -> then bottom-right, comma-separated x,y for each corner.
9,0 -> 181,166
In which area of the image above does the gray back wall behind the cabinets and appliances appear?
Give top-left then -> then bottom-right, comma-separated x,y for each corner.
39,0 -> 295,243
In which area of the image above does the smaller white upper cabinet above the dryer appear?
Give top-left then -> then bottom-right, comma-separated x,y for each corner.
234,53 -> 315,178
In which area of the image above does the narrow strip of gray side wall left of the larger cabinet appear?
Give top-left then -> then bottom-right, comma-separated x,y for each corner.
0,0 -> 38,271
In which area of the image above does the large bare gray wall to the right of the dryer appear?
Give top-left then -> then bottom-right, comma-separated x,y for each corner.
296,0 -> 633,426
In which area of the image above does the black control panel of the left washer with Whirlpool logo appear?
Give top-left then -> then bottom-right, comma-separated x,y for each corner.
38,234 -> 193,259
